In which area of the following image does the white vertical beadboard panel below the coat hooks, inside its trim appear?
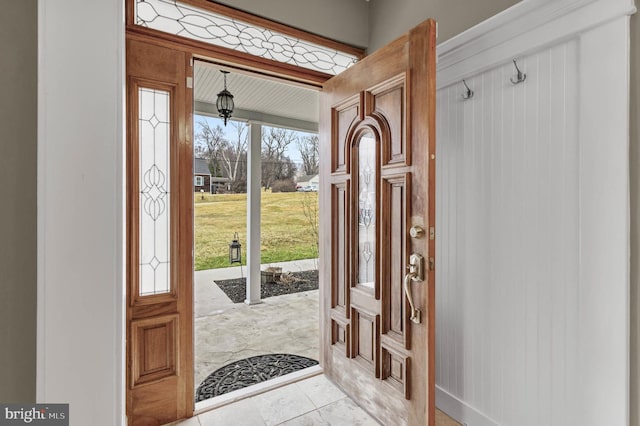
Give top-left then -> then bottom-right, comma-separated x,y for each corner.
436,41 -> 579,426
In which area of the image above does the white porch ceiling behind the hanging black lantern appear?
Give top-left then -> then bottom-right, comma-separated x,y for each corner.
194,61 -> 318,128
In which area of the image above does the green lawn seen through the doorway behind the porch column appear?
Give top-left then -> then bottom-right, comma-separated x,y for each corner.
194,192 -> 318,271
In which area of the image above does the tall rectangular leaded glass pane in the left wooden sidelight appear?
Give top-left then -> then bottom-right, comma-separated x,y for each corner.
138,88 -> 171,296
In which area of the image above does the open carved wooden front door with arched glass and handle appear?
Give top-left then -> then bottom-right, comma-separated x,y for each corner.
320,20 -> 436,425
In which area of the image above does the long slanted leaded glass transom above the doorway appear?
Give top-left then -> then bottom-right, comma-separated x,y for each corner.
135,0 -> 358,75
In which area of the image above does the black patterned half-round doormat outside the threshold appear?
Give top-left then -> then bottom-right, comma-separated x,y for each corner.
196,354 -> 318,402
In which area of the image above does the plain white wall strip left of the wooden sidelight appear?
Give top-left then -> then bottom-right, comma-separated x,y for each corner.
37,0 -> 124,426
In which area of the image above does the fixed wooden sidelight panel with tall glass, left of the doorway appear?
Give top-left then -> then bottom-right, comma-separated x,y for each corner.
126,36 -> 194,425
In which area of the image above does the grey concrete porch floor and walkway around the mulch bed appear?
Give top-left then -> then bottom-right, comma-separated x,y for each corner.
194,259 -> 320,387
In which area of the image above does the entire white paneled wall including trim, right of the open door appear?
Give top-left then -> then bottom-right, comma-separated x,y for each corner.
436,1 -> 632,425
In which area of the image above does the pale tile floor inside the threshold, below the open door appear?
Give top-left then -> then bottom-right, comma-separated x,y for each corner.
172,375 -> 460,426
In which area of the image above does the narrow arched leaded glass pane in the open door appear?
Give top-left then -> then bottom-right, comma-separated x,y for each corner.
358,132 -> 376,288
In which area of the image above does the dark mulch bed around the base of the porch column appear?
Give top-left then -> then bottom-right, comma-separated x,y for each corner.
216,270 -> 318,303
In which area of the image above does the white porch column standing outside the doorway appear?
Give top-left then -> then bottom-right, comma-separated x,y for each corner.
244,122 -> 262,305
